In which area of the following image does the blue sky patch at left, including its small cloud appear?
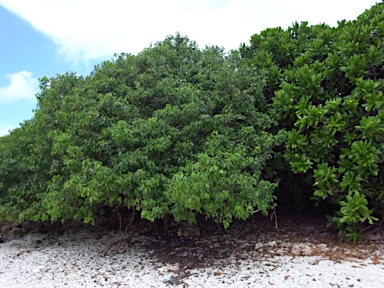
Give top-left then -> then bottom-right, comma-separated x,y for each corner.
0,6 -> 99,136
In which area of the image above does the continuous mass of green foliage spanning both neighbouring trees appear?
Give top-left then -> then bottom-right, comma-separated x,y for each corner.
0,4 -> 384,241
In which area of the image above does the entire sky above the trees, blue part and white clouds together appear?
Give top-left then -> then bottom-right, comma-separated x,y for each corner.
0,0 -> 377,136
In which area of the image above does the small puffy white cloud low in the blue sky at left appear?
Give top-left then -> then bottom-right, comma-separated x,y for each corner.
0,70 -> 39,103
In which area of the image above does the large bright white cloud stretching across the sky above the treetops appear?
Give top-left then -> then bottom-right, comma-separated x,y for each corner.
0,0 -> 376,62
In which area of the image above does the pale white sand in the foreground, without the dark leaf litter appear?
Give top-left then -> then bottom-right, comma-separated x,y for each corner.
0,230 -> 384,288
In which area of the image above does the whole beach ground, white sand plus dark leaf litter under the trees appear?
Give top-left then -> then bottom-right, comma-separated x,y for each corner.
0,215 -> 384,288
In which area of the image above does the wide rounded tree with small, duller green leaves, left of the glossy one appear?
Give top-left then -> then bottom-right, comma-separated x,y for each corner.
0,35 -> 283,226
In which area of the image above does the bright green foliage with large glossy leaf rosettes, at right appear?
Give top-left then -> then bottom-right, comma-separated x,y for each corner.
241,4 -> 384,241
